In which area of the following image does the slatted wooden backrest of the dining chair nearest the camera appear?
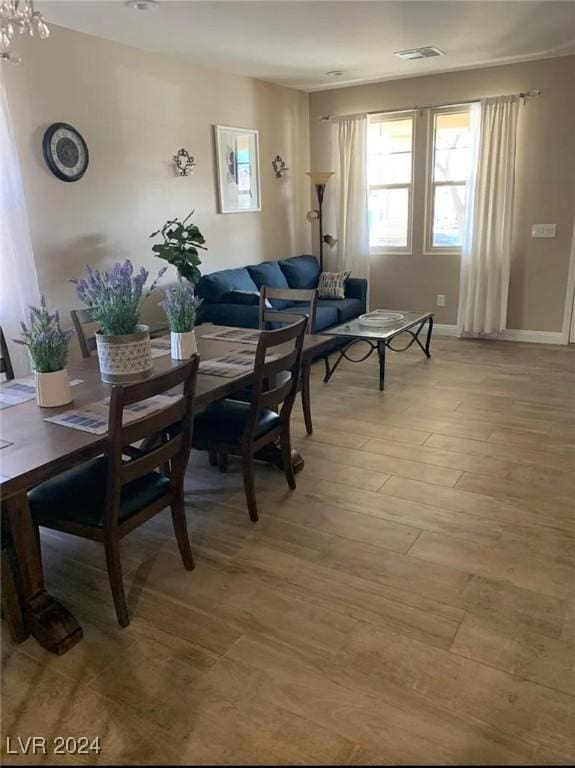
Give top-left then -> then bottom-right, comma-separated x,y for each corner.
106,355 -> 199,526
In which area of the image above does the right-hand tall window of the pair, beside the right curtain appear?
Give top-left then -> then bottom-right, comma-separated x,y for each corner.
426,107 -> 471,251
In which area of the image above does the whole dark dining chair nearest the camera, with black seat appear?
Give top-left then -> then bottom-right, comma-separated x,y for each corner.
28,356 -> 199,627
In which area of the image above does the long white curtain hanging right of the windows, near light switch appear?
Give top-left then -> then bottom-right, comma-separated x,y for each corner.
457,96 -> 519,336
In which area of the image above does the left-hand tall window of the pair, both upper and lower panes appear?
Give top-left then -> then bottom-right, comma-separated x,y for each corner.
367,112 -> 414,252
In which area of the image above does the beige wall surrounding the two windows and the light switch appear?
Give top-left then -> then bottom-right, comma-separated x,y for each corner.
310,56 -> 575,331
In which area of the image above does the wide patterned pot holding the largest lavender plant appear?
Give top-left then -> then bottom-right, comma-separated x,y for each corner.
96,325 -> 154,384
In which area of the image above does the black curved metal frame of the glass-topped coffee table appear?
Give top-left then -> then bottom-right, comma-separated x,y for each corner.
323,312 -> 433,391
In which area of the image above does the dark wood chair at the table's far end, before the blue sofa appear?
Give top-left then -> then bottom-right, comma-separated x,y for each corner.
259,286 -> 317,435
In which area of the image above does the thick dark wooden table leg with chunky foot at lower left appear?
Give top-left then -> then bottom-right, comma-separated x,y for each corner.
4,493 -> 83,655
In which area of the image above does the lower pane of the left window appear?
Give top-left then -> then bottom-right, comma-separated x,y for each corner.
369,188 -> 409,248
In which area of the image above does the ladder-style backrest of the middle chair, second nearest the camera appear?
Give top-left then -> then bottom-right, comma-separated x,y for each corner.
244,317 -> 308,440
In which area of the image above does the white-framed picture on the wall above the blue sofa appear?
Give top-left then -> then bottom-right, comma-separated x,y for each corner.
214,125 -> 262,213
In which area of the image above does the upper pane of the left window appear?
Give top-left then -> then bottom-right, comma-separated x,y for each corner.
367,117 -> 413,185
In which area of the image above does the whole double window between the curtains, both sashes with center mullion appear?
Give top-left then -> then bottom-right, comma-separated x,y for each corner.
367,105 -> 473,254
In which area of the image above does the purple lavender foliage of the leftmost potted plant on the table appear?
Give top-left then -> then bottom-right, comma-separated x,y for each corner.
16,296 -> 73,373
